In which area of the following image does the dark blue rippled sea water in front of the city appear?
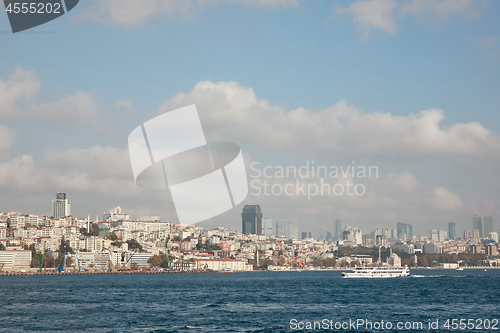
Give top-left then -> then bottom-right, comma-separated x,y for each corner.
0,269 -> 500,332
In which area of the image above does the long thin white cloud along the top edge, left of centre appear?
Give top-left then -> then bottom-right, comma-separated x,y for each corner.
73,0 -> 299,27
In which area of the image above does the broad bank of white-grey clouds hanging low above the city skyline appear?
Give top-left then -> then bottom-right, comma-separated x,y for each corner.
0,75 -> 500,231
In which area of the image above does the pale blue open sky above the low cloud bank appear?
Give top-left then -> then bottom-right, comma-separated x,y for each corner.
0,0 -> 500,233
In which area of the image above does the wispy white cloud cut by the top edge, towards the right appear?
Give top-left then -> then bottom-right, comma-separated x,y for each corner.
335,0 -> 488,38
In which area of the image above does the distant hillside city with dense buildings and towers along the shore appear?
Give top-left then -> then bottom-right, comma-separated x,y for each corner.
0,193 -> 500,273
